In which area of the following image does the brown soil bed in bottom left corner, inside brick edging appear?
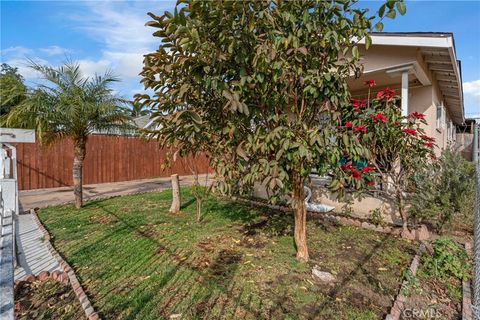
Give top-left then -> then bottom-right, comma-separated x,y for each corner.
15,280 -> 86,320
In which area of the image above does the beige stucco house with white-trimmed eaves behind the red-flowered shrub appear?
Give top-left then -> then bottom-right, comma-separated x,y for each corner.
349,32 -> 465,155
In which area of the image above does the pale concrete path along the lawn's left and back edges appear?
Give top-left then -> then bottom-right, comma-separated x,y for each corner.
15,176 -> 205,280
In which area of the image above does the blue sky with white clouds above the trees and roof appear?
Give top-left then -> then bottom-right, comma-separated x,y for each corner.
0,0 -> 480,115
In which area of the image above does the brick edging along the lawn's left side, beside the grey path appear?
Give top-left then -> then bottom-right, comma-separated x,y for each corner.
30,210 -> 101,320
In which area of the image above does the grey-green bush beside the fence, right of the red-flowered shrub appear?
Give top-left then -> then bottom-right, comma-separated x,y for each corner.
410,149 -> 476,233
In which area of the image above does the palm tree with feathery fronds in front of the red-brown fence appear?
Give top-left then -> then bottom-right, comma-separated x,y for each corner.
5,61 -> 130,208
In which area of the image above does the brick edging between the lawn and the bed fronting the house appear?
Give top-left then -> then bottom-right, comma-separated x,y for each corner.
228,197 -> 430,241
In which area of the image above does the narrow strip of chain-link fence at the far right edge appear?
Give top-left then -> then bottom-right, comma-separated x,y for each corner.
472,161 -> 480,320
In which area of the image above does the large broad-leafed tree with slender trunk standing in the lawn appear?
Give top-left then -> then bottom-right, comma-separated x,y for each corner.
137,0 -> 405,261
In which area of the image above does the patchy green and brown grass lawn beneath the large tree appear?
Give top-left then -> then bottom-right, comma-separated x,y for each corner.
39,188 -> 417,319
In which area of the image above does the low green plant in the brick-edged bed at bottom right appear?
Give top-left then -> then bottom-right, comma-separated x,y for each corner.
421,239 -> 471,280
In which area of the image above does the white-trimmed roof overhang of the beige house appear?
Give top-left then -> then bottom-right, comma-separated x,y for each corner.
360,32 -> 465,124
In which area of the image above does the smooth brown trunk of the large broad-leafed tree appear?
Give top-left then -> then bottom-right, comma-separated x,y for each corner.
292,172 -> 308,262
